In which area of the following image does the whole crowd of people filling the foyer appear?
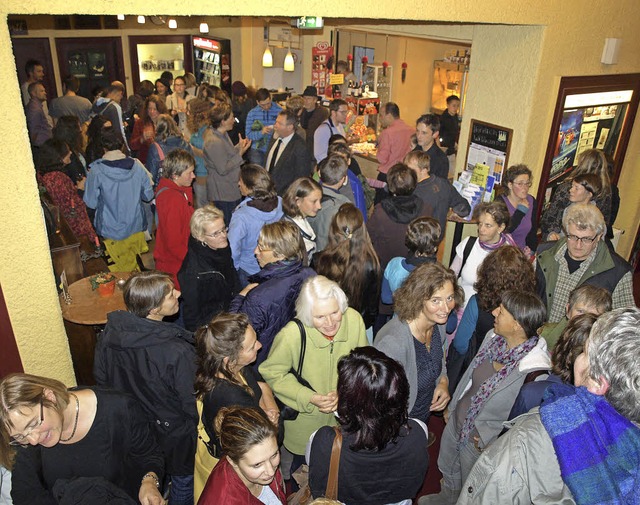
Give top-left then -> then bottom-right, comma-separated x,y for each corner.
0,61 -> 640,505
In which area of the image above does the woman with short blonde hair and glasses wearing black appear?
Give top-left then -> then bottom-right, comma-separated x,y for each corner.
178,205 -> 240,331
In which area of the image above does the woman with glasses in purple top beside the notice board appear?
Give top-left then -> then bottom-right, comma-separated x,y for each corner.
502,165 -> 538,257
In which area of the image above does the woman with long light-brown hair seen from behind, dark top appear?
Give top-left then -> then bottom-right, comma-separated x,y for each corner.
315,203 -> 380,328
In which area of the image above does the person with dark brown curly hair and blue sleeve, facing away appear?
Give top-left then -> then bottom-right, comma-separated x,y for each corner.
447,246 -> 536,393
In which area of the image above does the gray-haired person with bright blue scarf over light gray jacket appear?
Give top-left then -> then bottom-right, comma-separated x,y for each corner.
458,307 -> 640,505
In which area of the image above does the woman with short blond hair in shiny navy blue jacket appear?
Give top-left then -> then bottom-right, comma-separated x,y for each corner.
229,221 -> 315,366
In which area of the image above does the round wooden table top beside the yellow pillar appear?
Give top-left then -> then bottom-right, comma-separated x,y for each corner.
60,272 -> 131,325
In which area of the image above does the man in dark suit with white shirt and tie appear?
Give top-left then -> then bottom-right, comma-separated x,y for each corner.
265,110 -> 313,196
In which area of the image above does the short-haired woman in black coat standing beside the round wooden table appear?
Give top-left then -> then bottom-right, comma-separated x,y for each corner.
93,271 -> 198,504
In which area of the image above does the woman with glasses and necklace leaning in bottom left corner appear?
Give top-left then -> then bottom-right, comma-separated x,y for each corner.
0,373 -> 164,505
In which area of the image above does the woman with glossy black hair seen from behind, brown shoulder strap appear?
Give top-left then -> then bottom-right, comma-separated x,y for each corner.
307,347 -> 429,505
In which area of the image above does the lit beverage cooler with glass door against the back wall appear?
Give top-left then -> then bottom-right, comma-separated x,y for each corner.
192,36 -> 232,95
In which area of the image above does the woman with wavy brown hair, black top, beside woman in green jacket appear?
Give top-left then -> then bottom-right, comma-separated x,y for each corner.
194,312 -> 280,501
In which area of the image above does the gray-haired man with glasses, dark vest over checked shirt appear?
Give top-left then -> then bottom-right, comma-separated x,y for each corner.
536,204 -> 635,323
